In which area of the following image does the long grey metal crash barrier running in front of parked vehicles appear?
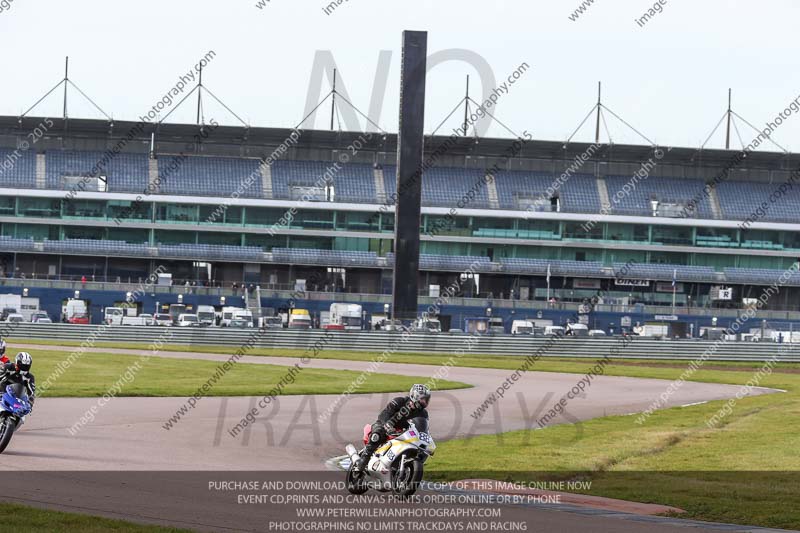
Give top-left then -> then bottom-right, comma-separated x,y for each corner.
7,323 -> 800,362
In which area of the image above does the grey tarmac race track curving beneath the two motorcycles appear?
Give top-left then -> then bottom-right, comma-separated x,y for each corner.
0,347 -> 784,531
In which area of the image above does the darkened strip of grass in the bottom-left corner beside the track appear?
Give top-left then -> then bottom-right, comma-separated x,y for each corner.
0,503 -> 188,533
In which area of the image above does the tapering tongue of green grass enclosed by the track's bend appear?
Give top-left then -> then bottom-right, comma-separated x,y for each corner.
31,349 -> 469,397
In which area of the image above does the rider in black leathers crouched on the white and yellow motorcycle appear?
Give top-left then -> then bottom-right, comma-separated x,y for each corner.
356,383 -> 431,472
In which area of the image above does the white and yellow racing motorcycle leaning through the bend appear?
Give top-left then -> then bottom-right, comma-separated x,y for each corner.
345,417 -> 436,497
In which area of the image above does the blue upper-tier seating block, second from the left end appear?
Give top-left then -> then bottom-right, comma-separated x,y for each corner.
46,150 -> 148,193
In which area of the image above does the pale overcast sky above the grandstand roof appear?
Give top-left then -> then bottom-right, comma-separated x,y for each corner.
0,0 -> 800,152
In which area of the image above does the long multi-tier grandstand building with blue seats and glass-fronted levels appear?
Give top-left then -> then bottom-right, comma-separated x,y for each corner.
0,117 -> 800,328
